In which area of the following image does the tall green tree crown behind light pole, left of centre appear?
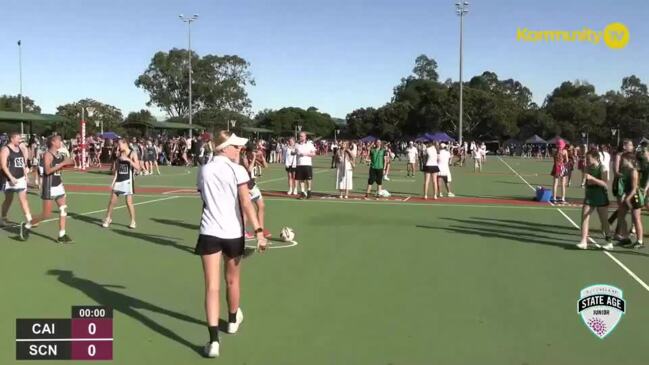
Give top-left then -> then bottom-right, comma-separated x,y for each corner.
135,48 -> 255,117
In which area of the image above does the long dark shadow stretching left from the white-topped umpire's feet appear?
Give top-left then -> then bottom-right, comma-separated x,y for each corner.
47,270 -> 206,353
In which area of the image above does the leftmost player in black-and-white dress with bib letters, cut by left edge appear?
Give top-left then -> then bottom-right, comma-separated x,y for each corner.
0,132 -> 32,229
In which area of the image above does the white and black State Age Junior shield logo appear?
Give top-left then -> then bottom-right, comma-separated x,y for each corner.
577,284 -> 626,339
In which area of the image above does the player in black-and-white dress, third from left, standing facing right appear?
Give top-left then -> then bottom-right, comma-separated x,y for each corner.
102,138 -> 140,229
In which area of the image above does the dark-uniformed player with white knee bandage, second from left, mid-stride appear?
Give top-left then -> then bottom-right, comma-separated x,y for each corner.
20,136 -> 74,243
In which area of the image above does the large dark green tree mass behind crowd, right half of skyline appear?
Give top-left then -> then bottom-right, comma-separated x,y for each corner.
346,55 -> 649,142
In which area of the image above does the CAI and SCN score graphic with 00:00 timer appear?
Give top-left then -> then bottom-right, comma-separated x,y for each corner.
16,306 -> 113,360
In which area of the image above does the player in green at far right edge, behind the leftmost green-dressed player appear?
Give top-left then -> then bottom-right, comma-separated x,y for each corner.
618,152 -> 645,248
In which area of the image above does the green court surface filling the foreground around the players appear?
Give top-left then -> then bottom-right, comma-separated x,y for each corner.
0,156 -> 649,365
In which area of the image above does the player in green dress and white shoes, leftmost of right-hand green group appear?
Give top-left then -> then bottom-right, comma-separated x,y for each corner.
577,151 -> 613,250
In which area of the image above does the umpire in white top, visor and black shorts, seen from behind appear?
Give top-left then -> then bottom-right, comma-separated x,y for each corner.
195,131 -> 267,357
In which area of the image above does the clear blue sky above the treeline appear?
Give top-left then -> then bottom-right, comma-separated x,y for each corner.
0,0 -> 649,118
